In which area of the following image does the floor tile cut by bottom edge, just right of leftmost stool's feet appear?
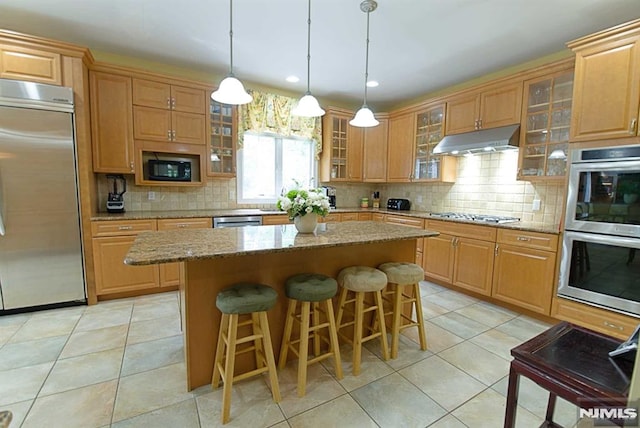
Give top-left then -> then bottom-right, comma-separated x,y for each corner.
289,394 -> 378,428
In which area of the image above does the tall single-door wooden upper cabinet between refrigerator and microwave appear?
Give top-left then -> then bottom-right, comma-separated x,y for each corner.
89,71 -> 134,174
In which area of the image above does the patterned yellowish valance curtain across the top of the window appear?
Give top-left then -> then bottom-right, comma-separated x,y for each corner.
238,90 -> 322,157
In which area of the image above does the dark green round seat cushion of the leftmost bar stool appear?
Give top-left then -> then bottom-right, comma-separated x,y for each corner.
216,282 -> 278,314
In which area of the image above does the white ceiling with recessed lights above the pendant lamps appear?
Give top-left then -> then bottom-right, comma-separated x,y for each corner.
0,0 -> 640,111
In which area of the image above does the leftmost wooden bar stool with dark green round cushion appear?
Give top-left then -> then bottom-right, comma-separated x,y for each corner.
211,282 -> 280,424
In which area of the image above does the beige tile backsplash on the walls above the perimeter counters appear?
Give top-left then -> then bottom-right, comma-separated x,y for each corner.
98,152 -> 565,229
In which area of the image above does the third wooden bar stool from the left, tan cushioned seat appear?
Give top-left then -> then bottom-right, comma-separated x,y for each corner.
336,266 -> 389,376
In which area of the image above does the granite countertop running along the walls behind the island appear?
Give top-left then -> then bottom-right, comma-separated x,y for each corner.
91,207 -> 560,235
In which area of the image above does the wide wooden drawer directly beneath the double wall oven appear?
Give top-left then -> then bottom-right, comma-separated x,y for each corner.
551,297 -> 640,339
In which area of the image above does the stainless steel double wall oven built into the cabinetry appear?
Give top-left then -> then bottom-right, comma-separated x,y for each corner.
558,146 -> 640,316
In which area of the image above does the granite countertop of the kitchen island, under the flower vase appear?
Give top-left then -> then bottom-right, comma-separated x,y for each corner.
125,221 -> 438,265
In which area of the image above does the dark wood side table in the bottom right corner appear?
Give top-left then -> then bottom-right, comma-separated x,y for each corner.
504,322 -> 633,428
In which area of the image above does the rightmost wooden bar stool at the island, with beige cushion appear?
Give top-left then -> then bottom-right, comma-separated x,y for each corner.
378,262 -> 427,358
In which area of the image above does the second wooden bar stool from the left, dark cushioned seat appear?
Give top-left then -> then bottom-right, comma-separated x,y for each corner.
278,273 -> 342,397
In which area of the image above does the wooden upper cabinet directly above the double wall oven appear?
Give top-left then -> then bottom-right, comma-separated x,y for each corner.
567,20 -> 640,142
